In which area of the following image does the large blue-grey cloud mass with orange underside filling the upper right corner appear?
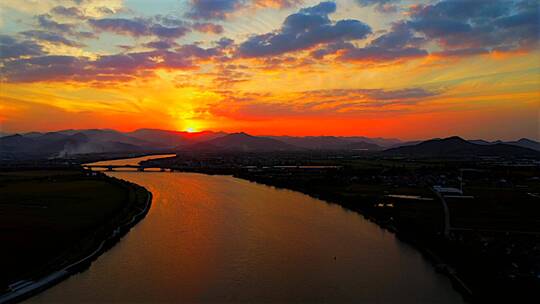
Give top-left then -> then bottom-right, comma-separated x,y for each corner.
336,0 -> 540,62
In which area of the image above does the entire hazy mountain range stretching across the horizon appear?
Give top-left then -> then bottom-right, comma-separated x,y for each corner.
0,129 -> 540,160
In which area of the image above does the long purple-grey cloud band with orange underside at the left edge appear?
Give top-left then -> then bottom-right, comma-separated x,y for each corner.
0,42 -> 230,82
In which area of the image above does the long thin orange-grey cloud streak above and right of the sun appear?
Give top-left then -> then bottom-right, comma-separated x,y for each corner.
207,88 -> 441,120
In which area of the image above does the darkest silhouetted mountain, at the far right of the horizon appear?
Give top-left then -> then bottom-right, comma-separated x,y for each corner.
383,136 -> 540,158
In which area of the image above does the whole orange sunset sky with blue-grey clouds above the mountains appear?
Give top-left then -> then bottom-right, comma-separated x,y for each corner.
0,0 -> 540,140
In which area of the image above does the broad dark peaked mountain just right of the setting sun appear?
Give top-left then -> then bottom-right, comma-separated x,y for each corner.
191,132 -> 300,152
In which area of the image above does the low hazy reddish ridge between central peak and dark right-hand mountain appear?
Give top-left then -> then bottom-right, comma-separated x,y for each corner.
268,136 -> 382,151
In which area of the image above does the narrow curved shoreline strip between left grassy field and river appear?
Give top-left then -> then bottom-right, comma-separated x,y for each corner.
0,176 -> 153,304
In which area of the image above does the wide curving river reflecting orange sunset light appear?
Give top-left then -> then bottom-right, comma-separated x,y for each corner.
28,156 -> 462,303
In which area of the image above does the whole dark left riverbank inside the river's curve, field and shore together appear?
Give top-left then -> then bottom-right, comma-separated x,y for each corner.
0,168 -> 152,303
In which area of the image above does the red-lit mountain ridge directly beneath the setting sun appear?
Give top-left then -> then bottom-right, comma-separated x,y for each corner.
130,129 -> 227,148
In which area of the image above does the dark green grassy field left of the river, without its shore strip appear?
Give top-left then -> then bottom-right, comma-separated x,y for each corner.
0,171 -> 134,290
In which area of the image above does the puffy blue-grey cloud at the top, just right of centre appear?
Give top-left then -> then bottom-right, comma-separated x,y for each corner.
239,2 -> 371,57
